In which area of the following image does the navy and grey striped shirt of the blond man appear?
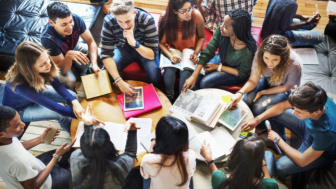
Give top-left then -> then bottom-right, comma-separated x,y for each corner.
100,8 -> 159,60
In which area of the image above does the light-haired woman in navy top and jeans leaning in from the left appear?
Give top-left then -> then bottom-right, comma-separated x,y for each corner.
2,41 -> 98,133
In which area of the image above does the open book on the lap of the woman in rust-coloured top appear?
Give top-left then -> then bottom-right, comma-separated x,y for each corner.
160,49 -> 205,75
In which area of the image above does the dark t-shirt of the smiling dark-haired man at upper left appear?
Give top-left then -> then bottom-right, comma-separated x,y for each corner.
41,14 -> 86,56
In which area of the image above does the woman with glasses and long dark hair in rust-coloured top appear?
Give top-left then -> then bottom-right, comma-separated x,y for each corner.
159,0 -> 204,103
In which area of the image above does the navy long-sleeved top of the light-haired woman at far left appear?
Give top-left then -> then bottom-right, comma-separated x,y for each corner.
2,78 -> 76,118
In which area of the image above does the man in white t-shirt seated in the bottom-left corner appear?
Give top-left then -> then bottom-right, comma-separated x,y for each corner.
0,106 -> 75,189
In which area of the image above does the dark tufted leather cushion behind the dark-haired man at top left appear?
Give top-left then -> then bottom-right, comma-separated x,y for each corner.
0,0 -> 101,71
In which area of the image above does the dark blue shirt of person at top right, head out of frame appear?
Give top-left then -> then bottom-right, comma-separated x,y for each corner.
260,0 -> 298,43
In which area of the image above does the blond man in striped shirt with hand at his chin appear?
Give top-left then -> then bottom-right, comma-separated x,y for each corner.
100,0 -> 161,95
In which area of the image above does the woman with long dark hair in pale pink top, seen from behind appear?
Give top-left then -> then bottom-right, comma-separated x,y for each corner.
140,116 -> 196,189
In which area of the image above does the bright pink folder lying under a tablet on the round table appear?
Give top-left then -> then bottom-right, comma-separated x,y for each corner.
117,84 -> 162,119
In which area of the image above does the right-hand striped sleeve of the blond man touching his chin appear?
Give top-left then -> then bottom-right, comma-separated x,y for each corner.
144,16 -> 159,57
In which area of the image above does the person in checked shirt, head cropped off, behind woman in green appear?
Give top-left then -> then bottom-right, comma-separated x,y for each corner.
197,0 -> 258,32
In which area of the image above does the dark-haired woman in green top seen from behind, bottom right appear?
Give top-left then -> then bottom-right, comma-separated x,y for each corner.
201,133 -> 279,189
